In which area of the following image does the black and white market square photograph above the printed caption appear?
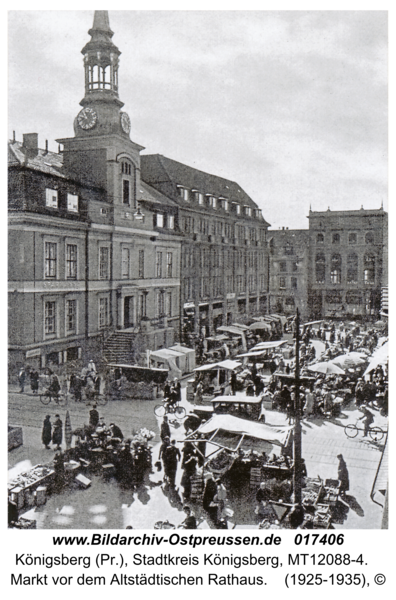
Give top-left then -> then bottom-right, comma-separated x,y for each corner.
7,5 -> 389,535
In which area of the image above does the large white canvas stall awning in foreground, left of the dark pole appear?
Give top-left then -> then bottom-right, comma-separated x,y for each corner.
197,415 -> 293,446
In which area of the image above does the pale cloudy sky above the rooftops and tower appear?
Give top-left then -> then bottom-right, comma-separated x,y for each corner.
8,7 -> 388,228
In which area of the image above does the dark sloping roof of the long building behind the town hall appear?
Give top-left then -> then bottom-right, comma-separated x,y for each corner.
141,154 -> 258,208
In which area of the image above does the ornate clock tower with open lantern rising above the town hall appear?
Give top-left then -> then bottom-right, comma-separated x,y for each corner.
57,10 -> 143,202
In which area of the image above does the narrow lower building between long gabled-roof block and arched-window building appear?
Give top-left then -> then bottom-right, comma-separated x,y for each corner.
267,228 -> 309,319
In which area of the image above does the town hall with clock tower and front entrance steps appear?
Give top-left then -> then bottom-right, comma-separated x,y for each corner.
9,11 -> 180,366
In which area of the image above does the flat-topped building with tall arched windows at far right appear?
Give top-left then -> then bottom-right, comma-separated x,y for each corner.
308,208 -> 388,318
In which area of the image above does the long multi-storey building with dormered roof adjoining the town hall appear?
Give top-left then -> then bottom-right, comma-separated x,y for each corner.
141,154 -> 269,339
